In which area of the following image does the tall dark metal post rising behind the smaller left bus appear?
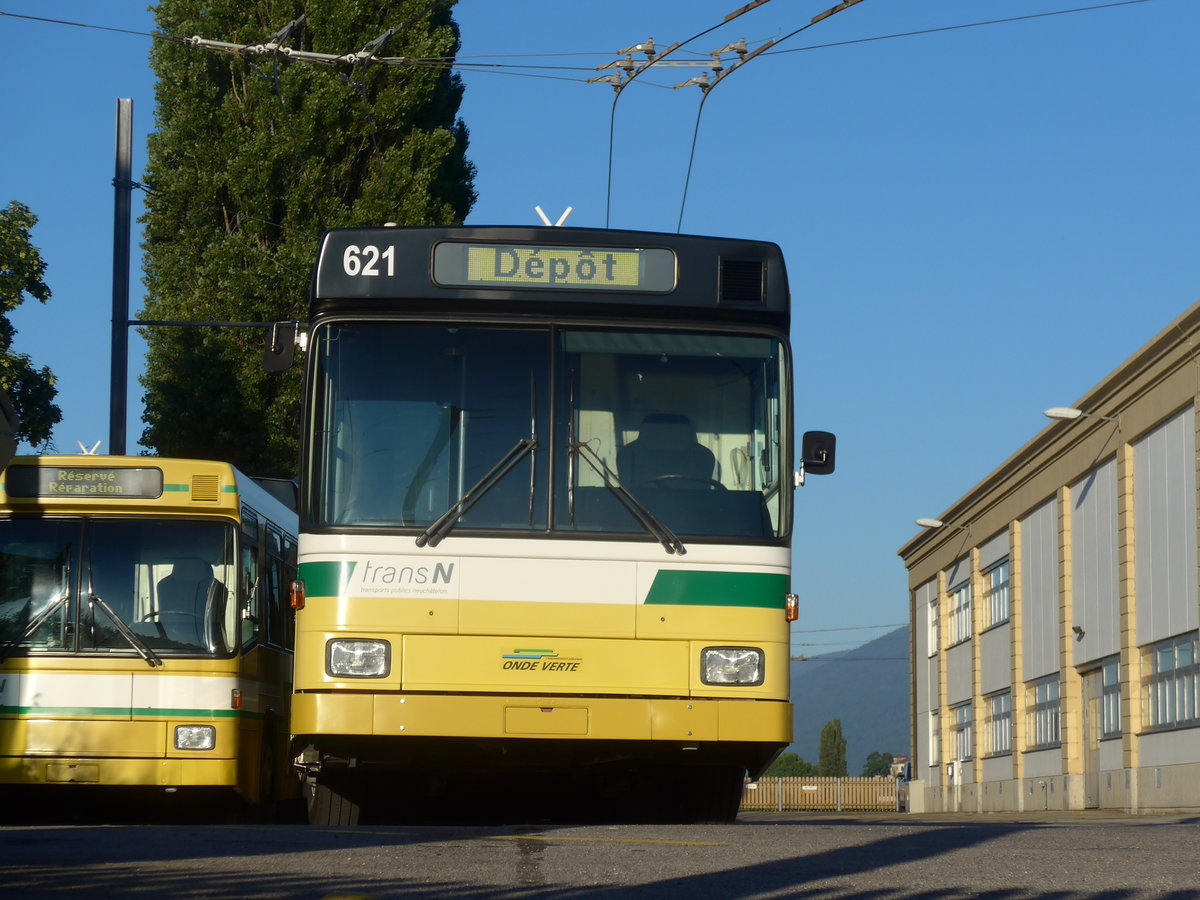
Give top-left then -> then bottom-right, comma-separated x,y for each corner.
108,97 -> 133,456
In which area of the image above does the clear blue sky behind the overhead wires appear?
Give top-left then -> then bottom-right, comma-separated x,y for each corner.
0,0 -> 1200,654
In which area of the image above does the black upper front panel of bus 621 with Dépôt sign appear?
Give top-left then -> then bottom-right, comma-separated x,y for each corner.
311,226 -> 790,330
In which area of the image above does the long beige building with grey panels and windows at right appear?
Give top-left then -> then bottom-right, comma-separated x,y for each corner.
899,302 -> 1200,812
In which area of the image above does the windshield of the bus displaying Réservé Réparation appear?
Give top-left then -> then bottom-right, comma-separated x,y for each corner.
0,517 -> 238,659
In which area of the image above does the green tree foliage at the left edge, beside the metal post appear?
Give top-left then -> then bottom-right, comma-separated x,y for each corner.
0,200 -> 62,446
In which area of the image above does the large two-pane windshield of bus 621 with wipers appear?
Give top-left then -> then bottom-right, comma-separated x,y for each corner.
310,322 -> 791,544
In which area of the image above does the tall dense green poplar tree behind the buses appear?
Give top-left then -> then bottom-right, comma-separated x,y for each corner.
142,0 -> 475,476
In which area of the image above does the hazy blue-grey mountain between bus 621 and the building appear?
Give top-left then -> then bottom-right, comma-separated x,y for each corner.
787,626 -> 911,775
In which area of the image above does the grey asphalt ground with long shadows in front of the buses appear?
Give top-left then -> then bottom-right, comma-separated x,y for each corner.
0,812 -> 1200,900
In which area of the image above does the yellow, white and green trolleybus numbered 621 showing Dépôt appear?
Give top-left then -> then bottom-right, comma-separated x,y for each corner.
293,227 -> 834,823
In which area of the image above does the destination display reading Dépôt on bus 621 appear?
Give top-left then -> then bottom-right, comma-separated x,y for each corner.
433,241 -> 676,294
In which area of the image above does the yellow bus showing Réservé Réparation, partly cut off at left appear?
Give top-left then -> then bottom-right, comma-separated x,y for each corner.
0,456 -> 296,803
